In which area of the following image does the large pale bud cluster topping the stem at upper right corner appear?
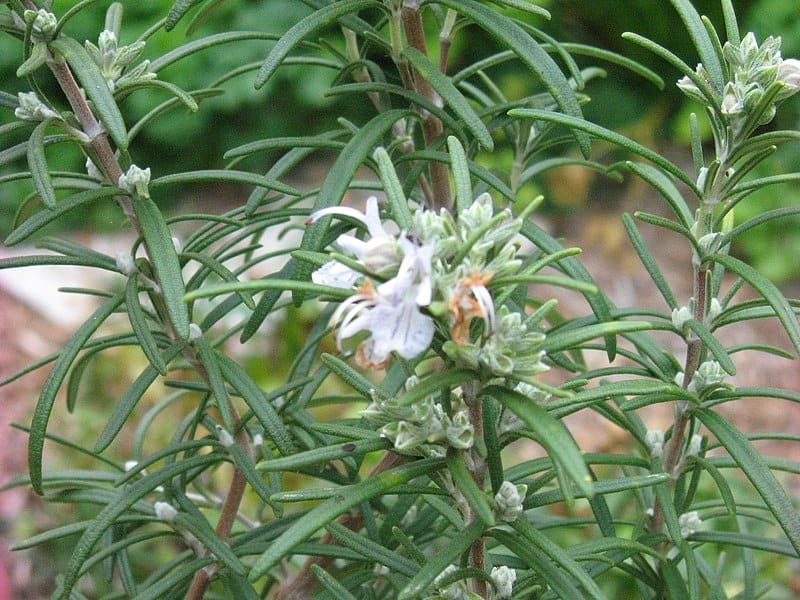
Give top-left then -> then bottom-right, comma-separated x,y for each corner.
678,33 -> 800,137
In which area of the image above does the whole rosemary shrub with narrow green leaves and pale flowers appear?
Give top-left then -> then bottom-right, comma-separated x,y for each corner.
0,0 -> 800,600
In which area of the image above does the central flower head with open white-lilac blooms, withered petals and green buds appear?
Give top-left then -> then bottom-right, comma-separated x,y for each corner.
310,194 -> 546,379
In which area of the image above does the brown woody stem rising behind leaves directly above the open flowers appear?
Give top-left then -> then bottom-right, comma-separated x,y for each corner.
402,6 -> 452,209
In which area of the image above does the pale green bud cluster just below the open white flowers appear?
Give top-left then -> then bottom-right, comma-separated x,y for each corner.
362,377 -> 474,457
